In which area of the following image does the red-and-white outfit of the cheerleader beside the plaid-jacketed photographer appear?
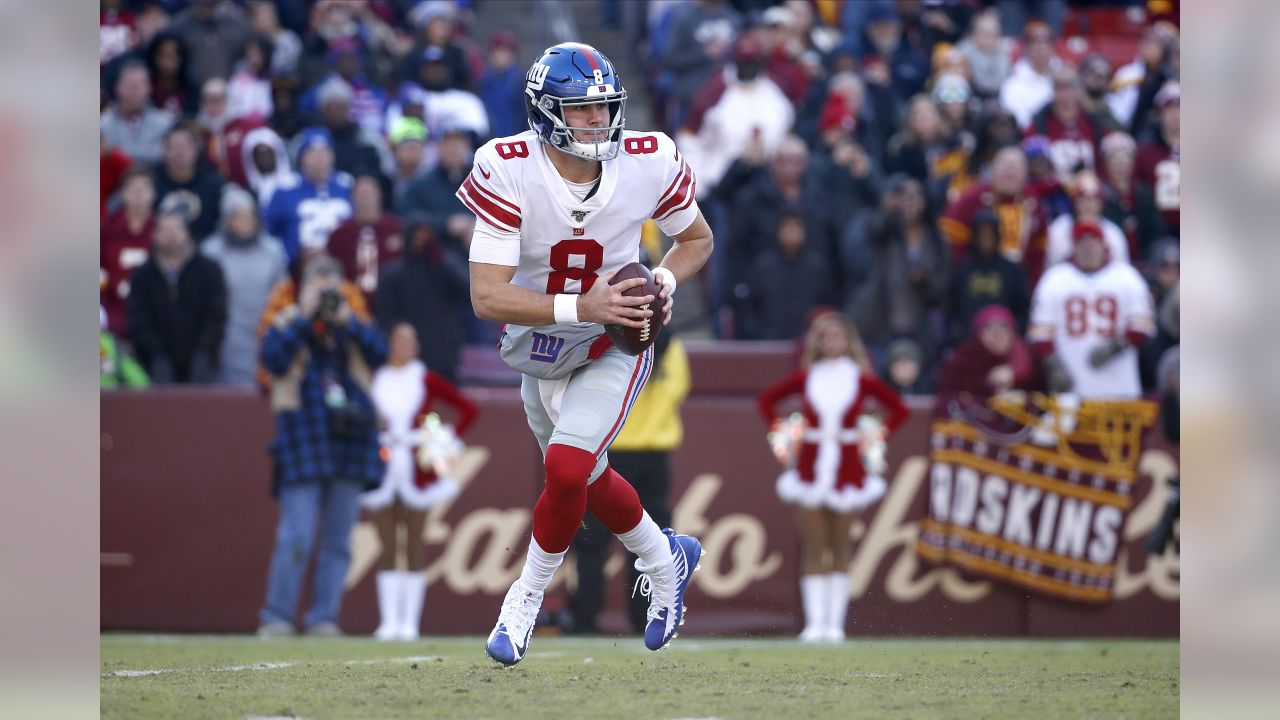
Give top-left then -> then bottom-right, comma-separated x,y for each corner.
360,360 -> 479,510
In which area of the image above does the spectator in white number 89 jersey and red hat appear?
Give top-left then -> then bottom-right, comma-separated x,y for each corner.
1027,222 -> 1156,400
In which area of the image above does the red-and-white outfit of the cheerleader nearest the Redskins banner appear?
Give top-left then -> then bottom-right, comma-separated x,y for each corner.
756,357 -> 908,512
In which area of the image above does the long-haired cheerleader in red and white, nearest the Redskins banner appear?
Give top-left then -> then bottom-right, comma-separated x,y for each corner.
758,311 -> 908,642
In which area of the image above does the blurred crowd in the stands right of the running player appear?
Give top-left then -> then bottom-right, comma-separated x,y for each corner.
629,0 -> 1180,392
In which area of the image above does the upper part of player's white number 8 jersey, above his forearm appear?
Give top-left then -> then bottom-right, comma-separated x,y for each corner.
457,131 -> 698,295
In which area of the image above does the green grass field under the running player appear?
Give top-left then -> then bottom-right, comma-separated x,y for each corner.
101,634 -> 1179,720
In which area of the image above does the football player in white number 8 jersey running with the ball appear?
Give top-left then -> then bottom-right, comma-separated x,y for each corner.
458,42 -> 712,665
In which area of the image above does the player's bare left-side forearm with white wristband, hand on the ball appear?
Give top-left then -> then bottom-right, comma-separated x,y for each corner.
471,260 -> 653,328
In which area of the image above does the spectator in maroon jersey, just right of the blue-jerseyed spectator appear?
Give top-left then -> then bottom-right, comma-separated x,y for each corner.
328,176 -> 404,305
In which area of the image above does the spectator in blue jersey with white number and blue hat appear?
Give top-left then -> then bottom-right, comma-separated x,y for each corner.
265,128 -> 353,264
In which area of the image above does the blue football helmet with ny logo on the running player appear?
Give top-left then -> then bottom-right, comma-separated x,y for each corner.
525,42 -> 627,160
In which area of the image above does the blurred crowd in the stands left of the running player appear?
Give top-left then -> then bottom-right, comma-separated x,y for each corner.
100,0 -> 509,386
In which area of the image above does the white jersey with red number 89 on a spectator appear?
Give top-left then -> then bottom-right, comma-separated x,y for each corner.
1027,263 -> 1156,400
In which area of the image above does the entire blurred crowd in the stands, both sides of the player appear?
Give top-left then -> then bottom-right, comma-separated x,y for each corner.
100,0 -> 1180,393
